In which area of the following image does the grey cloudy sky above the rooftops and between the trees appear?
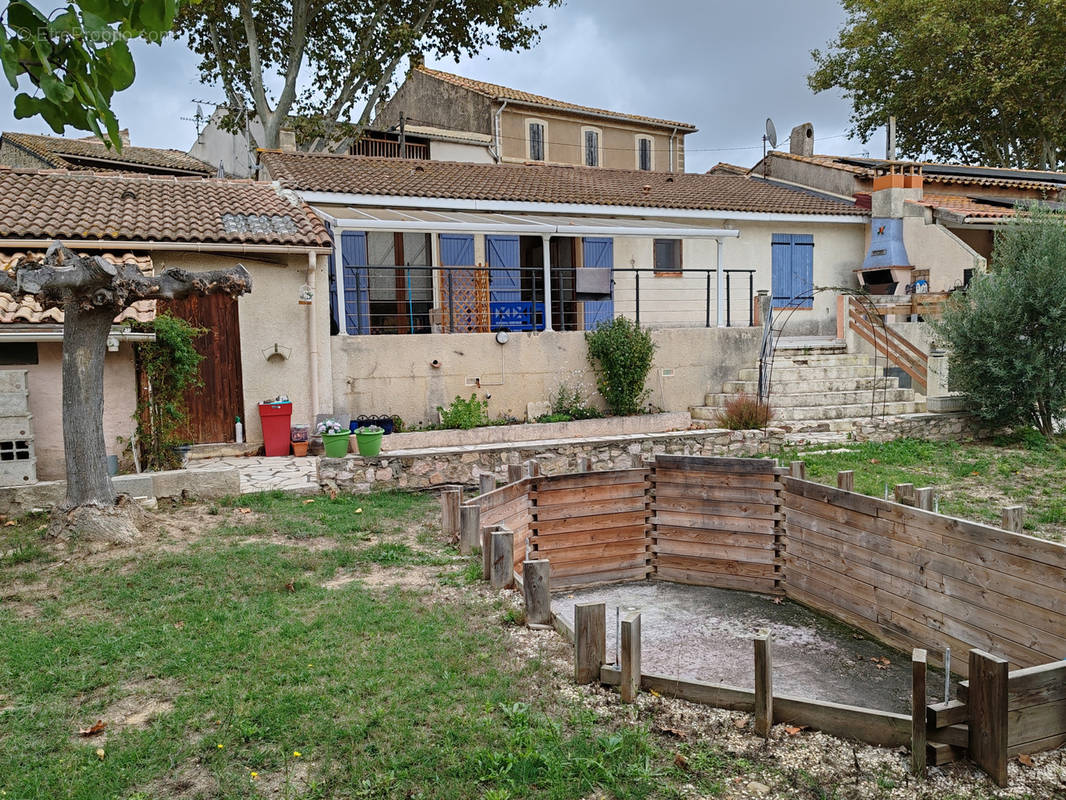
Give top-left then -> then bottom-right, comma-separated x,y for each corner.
0,0 -> 884,172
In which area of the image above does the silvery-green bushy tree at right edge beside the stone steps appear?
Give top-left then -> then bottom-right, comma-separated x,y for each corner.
935,207 -> 1066,436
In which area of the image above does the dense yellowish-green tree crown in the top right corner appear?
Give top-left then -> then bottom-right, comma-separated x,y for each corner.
808,0 -> 1066,169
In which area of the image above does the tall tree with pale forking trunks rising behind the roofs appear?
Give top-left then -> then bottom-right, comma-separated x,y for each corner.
178,0 -> 562,147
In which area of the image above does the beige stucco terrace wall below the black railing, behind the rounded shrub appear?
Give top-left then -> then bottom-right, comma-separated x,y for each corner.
330,327 -> 761,425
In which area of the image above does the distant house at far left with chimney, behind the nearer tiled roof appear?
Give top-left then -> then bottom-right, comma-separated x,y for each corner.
0,131 -> 215,177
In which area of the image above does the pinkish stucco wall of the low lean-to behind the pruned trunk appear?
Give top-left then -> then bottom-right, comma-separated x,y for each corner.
28,341 -> 136,480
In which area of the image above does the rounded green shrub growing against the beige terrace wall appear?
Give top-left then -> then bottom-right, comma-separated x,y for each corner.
585,317 -> 656,416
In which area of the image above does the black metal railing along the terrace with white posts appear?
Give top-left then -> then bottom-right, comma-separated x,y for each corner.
330,266 -> 756,334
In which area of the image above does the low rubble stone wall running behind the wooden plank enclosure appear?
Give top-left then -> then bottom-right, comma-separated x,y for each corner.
319,414 -> 978,493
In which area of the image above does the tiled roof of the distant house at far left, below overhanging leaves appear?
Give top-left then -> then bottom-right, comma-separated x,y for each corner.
3,131 -> 216,176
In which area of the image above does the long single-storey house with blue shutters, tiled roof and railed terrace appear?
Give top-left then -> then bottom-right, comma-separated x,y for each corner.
260,151 -> 869,422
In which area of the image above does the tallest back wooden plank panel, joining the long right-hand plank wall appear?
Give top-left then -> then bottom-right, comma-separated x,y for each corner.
651,455 -> 782,594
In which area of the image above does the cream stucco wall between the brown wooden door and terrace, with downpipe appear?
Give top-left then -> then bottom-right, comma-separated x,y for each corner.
162,253 -> 332,442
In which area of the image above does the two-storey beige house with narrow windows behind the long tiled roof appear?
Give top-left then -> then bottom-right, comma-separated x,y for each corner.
377,62 -> 696,172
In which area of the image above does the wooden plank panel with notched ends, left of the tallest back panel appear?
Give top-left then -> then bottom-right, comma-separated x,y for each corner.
530,467 -> 651,591
